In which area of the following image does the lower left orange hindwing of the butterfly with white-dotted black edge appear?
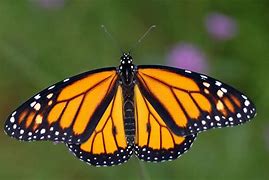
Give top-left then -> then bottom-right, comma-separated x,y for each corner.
67,86 -> 132,166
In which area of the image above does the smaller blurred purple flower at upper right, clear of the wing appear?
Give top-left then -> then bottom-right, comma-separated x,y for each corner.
205,13 -> 237,40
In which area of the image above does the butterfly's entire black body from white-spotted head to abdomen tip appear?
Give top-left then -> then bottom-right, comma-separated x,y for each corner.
118,53 -> 135,145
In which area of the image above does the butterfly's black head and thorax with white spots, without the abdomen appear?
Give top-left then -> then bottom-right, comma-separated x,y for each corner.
118,53 -> 135,85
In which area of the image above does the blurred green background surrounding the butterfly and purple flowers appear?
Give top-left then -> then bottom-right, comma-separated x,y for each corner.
0,0 -> 269,180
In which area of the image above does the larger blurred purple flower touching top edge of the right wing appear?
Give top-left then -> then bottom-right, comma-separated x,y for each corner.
167,43 -> 208,73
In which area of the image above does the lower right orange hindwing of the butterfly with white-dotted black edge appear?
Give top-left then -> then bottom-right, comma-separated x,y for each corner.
134,85 -> 196,162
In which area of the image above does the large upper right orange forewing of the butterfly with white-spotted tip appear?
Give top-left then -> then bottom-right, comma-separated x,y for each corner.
137,66 -> 256,136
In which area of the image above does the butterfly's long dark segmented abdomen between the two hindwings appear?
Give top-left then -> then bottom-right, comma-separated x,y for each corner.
123,85 -> 135,145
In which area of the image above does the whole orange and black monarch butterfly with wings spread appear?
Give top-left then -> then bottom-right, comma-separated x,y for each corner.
5,53 -> 256,166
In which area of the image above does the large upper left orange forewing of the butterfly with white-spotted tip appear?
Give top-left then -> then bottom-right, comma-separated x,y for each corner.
5,68 -> 117,143
